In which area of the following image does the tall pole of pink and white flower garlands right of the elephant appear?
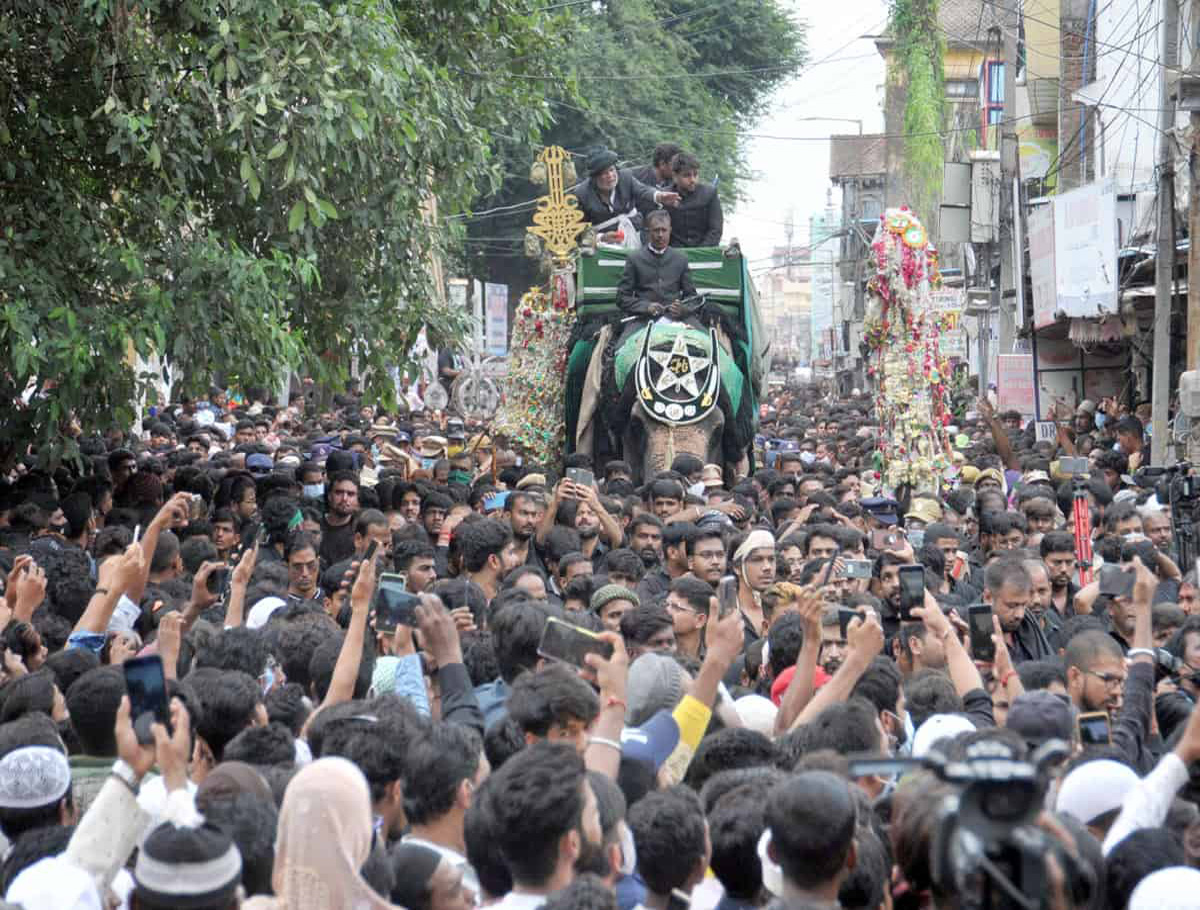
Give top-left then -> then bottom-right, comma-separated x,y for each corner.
863,206 -> 958,492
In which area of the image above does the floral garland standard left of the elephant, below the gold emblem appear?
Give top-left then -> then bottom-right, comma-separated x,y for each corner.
493,271 -> 575,465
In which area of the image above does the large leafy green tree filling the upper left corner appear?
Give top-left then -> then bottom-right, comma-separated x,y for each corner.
0,0 -> 563,458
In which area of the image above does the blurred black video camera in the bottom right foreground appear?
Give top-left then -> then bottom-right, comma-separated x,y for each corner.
850,740 -> 1096,910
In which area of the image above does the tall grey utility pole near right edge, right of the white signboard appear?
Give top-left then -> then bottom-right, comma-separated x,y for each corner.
1150,0 -> 1176,465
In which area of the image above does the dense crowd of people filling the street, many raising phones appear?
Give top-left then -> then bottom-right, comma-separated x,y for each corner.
0,387 -> 1200,910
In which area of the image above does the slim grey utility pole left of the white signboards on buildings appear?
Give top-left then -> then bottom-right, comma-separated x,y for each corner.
992,16 -> 1024,364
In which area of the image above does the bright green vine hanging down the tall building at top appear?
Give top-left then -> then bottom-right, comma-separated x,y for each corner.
888,0 -> 946,223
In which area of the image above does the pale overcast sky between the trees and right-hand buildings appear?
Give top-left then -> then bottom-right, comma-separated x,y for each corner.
725,0 -> 887,259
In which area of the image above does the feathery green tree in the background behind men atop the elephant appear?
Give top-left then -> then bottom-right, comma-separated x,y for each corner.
469,0 -> 805,287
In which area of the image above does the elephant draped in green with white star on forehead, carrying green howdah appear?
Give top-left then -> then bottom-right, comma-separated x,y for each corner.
566,247 -> 768,481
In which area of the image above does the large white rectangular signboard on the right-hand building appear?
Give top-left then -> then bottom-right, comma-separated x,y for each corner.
1054,180 -> 1120,317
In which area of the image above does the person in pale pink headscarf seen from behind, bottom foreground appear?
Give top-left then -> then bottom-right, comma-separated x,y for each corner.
244,759 -> 394,910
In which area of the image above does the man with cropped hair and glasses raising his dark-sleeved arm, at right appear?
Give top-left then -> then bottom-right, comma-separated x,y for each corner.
1063,557 -> 1158,773
